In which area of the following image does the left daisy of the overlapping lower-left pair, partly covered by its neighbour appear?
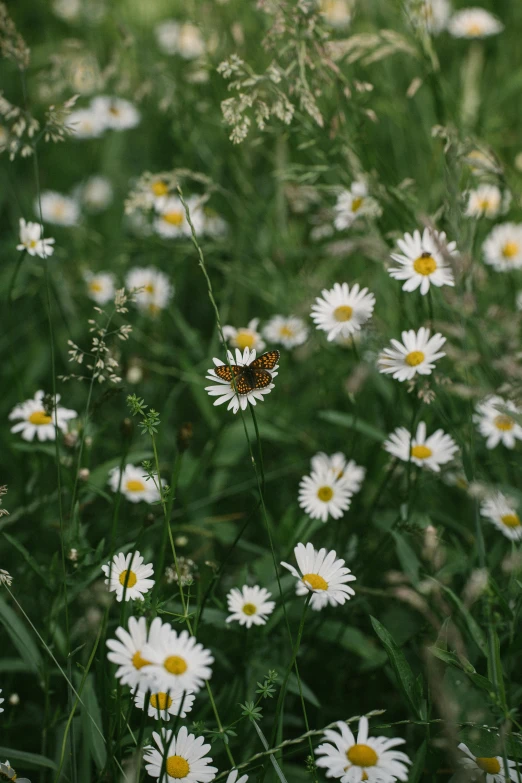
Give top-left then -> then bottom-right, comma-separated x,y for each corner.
107,617 -> 162,692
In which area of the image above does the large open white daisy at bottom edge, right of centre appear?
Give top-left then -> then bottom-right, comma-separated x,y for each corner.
315,716 -> 411,783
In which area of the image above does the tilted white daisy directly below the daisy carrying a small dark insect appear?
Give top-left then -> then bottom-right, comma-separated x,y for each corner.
378,326 -> 446,381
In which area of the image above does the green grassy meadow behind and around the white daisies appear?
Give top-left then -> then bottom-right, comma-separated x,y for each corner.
0,0 -> 522,783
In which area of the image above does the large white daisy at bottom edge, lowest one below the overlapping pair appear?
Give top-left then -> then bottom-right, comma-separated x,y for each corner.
143,726 -> 217,783
